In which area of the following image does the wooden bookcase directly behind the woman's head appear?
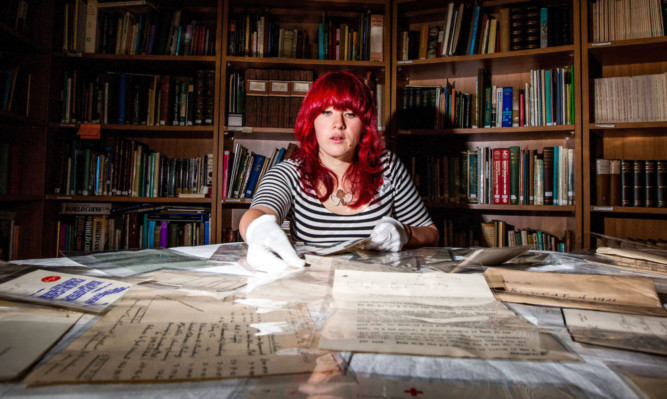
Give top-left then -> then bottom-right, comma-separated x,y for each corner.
216,0 -> 391,239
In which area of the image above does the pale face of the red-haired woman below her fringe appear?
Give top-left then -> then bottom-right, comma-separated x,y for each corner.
313,106 -> 363,164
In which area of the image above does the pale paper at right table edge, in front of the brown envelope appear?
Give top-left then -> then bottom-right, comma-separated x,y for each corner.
563,309 -> 667,355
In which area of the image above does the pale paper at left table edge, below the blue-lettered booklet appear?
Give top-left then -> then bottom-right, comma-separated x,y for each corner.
0,305 -> 81,380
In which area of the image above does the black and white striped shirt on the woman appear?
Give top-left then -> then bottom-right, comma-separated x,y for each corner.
250,151 -> 433,245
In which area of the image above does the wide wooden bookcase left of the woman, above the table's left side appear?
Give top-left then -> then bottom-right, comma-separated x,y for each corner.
43,0 -> 222,256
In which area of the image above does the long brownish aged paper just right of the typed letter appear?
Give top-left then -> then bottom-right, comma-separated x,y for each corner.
484,268 -> 667,316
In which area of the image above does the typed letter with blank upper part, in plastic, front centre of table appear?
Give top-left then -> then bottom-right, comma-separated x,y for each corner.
320,270 -> 574,360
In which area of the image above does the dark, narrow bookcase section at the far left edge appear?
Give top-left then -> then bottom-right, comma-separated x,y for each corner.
0,1 -> 53,260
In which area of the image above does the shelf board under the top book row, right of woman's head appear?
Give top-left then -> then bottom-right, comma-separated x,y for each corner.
394,45 -> 574,79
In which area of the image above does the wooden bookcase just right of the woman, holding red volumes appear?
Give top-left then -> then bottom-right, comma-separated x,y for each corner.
391,0 -> 582,249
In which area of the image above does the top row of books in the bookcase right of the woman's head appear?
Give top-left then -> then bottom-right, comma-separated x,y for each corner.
398,2 -> 570,61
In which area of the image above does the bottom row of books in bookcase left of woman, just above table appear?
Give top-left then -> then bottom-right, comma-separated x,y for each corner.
56,203 -> 211,255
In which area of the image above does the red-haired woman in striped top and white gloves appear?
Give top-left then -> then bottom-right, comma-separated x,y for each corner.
239,72 -> 438,271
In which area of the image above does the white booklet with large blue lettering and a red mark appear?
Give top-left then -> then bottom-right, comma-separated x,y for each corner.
0,269 -> 132,313
